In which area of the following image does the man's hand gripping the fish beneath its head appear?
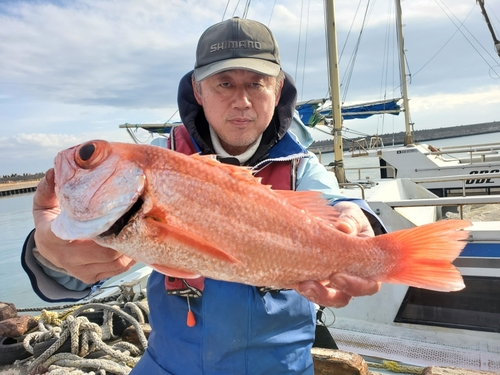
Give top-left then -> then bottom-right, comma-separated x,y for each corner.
33,169 -> 135,284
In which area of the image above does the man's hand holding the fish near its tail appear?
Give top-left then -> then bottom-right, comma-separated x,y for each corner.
297,202 -> 381,307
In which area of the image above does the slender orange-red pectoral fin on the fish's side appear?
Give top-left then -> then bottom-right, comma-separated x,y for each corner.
146,218 -> 241,264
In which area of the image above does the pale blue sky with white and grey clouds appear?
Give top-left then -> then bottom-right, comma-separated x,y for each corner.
0,0 -> 500,176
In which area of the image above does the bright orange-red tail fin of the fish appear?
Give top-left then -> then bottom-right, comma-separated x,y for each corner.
381,220 -> 471,292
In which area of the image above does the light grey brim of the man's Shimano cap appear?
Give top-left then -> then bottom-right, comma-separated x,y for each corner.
194,58 -> 281,81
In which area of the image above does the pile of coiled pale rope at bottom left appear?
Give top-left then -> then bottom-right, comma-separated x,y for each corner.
23,302 -> 149,375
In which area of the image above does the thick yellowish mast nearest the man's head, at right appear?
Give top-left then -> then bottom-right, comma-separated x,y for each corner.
325,0 -> 347,183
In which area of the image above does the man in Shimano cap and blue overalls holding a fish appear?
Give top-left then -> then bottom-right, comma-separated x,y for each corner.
23,18 -> 380,375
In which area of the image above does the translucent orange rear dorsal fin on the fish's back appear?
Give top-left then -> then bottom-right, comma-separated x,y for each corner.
273,190 -> 340,223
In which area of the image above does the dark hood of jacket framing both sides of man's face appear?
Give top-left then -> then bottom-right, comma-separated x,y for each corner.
177,71 -> 297,165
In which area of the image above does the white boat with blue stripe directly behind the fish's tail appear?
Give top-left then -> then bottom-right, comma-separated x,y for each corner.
336,179 -> 500,372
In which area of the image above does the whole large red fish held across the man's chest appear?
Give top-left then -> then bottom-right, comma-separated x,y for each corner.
52,141 -> 470,291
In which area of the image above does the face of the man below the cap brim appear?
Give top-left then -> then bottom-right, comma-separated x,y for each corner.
193,69 -> 281,155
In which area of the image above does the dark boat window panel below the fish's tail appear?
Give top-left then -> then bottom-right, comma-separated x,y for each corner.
394,276 -> 500,332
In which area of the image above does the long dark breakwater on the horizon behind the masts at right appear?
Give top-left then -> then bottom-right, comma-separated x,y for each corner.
309,121 -> 500,152
